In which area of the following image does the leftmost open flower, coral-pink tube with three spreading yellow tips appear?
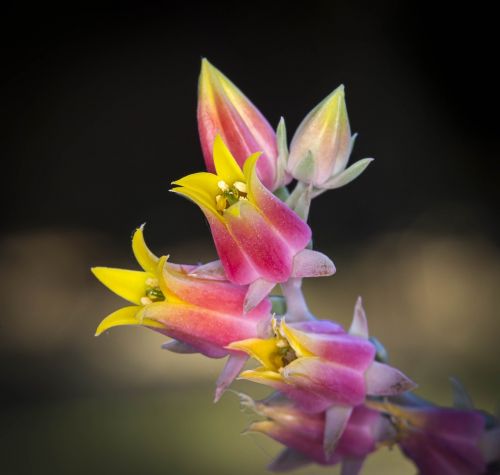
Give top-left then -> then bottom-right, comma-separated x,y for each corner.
92,227 -> 271,402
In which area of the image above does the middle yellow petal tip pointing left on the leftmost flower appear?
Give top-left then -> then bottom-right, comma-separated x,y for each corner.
91,267 -> 149,305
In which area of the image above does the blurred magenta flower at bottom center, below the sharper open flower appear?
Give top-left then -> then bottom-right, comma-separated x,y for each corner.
240,395 -> 394,475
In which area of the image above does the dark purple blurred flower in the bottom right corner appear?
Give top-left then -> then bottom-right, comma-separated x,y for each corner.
370,403 -> 490,475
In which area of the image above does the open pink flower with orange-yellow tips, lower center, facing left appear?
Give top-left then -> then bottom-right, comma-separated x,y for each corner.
228,299 -> 415,452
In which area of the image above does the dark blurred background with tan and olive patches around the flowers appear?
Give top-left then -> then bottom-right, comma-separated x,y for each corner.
0,1 -> 500,475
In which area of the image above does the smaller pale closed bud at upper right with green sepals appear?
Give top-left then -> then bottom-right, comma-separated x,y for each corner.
287,86 -> 372,196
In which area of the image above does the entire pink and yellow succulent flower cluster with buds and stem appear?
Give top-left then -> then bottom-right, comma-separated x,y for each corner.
92,59 -> 500,475
